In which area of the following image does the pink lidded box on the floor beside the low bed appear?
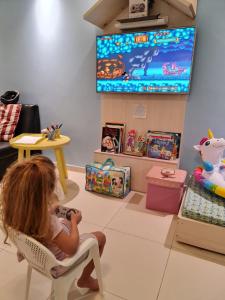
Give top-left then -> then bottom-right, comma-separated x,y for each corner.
146,166 -> 187,214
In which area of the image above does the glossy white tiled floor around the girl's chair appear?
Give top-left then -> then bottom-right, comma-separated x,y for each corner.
0,172 -> 225,300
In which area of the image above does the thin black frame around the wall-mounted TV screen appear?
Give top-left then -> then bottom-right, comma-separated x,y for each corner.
95,25 -> 197,95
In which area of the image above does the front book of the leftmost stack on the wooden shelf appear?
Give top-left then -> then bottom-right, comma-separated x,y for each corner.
101,126 -> 121,153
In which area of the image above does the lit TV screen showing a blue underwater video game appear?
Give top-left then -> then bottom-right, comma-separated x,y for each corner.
96,27 -> 195,94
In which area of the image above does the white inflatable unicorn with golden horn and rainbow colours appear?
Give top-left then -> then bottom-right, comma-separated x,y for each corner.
194,129 -> 225,198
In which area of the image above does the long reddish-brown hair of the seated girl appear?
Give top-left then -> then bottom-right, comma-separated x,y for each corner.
1,156 -> 56,242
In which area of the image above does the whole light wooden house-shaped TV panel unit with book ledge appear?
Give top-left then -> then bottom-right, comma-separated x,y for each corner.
84,0 -> 197,192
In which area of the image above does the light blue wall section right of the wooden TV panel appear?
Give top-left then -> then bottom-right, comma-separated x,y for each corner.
181,0 -> 225,171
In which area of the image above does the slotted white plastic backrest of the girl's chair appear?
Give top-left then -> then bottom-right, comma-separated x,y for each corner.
9,228 -> 59,277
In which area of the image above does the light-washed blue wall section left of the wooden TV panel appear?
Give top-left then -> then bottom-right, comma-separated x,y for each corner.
0,0 -> 100,165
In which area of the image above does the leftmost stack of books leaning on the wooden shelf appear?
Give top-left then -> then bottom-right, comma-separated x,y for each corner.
101,122 -> 125,153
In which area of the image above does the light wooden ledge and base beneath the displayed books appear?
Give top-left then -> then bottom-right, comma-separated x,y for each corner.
94,149 -> 180,193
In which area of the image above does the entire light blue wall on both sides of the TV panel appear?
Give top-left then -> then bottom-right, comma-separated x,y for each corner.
0,0 -> 225,171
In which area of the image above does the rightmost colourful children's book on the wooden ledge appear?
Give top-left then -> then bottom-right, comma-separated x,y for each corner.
147,130 -> 181,160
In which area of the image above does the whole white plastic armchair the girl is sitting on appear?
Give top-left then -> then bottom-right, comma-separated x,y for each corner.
6,229 -> 103,300
